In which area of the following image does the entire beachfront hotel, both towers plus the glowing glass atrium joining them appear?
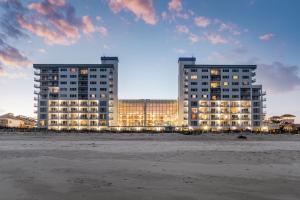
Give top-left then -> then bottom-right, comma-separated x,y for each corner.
33,57 -> 265,131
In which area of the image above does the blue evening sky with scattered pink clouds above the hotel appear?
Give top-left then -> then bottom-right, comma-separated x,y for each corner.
0,0 -> 300,123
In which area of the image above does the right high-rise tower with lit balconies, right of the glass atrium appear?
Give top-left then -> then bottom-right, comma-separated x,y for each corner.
178,57 -> 265,130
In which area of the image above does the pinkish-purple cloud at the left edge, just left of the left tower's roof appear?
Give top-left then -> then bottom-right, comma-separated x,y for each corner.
0,38 -> 32,67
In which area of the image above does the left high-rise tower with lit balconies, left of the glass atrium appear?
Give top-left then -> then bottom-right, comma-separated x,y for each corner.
33,57 -> 119,130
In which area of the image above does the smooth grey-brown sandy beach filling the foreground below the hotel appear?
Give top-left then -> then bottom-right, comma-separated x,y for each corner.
0,133 -> 300,200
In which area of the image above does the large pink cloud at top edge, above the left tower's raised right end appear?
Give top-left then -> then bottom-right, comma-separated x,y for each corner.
108,0 -> 157,25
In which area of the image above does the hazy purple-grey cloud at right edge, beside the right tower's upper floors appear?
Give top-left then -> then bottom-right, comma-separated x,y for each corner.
257,62 -> 300,94
